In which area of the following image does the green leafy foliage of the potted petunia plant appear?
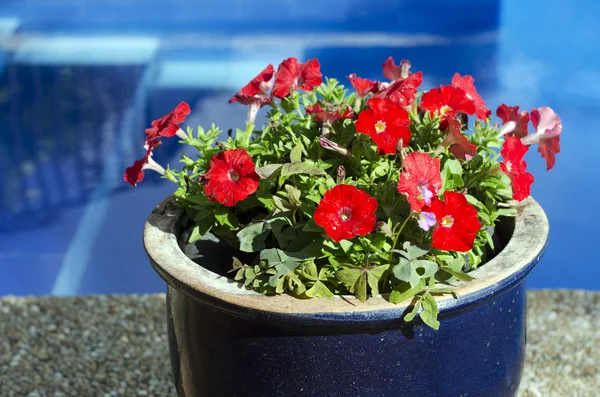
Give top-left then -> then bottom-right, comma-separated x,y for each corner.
165,79 -> 514,329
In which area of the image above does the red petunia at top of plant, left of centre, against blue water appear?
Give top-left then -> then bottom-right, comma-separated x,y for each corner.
271,58 -> 323,98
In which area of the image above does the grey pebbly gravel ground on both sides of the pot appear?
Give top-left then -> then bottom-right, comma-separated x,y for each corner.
0,290 -> 600,397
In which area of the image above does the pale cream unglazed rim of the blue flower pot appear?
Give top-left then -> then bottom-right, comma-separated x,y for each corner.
143,197 -> 549,325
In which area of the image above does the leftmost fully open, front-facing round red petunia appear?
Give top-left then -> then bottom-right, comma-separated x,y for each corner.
204,149 -> 260,207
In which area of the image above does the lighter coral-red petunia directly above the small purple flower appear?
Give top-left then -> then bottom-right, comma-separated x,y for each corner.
398,152 -> 442,212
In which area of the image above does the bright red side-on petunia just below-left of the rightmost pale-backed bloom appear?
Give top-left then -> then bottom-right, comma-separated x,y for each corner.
500,136 -> 533,201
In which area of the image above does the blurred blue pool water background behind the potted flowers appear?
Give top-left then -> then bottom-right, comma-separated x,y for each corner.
0,0 -> 600,295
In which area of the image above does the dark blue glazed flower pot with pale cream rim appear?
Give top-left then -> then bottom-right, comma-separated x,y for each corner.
144,198 -> 548,397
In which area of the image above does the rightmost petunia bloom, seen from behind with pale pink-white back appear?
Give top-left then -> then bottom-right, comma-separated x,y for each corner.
521,106 -> 562,171
